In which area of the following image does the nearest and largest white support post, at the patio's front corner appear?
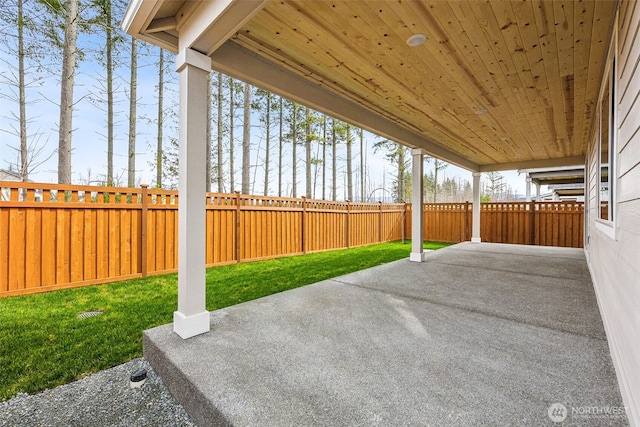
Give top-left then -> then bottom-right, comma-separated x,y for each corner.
173,49 -> 211,339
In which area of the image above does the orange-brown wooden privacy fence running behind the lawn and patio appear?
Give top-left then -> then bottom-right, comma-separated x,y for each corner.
0,182 -> 583,297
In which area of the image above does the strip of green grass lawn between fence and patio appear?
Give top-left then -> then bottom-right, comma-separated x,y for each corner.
0,242 -> 449,401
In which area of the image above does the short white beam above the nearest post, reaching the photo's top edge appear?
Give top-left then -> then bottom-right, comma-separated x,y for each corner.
177,0 -> 269,55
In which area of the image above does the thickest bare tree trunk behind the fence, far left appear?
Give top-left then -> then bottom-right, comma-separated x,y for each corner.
58,0 -> 78,184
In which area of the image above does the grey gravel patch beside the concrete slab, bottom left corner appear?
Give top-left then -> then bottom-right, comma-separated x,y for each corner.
0,358 -> 195,427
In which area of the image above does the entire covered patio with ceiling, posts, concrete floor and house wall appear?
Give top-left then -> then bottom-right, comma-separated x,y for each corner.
123,0 -> 640,425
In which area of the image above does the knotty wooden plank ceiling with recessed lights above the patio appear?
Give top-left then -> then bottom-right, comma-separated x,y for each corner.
134,0 -> 616,170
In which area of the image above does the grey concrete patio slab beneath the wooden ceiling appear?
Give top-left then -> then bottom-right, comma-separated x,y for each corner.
144,243 -> 628,427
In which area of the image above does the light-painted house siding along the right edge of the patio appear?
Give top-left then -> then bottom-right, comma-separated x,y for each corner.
585,1 -> 640,426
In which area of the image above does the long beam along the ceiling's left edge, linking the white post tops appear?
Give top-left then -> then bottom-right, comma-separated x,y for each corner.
211,42 -> 479,171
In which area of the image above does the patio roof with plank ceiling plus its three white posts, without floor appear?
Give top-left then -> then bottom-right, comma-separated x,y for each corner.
117,0 -> 616,339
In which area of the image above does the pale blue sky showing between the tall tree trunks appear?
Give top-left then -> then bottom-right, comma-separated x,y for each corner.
0,5 -> 525,198
